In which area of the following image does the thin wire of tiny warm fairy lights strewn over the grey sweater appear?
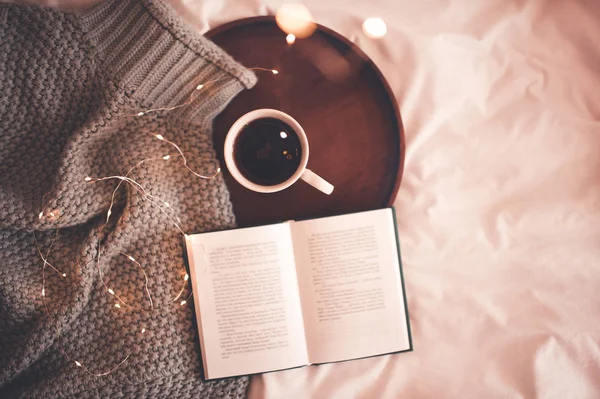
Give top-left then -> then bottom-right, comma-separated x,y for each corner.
33,64 -> 282,377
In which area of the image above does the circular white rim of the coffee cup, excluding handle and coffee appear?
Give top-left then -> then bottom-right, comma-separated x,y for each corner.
223,108 -> 309,193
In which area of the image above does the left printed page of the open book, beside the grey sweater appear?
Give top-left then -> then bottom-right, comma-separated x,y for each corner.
186,223 -> 308,379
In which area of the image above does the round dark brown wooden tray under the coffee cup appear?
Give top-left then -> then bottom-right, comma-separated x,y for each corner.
206,16 -> 404,226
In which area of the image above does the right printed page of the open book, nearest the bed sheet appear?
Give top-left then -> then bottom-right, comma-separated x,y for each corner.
291,209 -> 410,363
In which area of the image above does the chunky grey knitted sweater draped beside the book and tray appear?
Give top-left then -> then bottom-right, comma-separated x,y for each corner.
0,0 -> 256,398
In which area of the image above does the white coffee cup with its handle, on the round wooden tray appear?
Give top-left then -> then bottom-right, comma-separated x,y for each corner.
224,108 -> 333,195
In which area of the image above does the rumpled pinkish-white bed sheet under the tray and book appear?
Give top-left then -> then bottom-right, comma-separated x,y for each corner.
165,0 -> 600,399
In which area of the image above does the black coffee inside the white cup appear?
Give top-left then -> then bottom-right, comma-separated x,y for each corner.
233,118 -> 302,186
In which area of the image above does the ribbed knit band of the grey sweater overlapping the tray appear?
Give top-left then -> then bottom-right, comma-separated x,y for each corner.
79,0 -> 256,117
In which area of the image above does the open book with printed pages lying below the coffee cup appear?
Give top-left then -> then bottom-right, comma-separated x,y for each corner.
186,208 -> 412,379
